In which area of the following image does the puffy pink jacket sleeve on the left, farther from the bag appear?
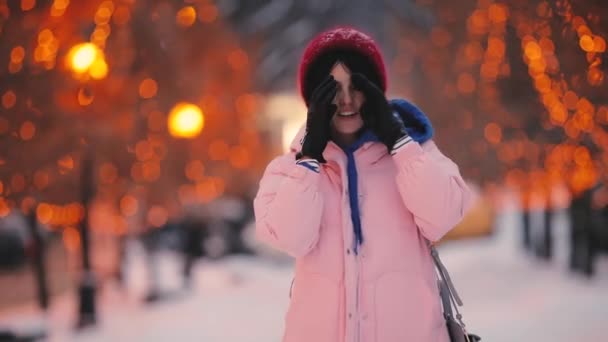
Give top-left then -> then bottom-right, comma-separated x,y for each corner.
253,153 -> 323,257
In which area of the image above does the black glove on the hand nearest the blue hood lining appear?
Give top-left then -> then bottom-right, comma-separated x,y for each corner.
351,73 -> 408,152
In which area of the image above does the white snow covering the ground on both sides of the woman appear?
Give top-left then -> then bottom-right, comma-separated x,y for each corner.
0,208 -> 608,342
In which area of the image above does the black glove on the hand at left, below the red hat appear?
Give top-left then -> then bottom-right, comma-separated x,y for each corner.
296,75 -> 338,163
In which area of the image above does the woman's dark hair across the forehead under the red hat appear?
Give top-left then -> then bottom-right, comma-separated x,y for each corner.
302,49 -> 382,103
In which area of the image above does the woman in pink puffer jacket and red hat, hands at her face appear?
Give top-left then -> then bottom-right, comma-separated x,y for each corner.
254,27 -> 470,342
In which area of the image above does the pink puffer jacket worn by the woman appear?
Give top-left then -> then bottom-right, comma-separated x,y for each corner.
254,104 -> 471,342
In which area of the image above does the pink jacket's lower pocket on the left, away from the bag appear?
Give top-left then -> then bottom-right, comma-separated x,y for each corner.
283,273 -> 340,342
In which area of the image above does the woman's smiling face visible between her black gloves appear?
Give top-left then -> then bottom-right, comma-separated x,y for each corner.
331,62 -> 365,135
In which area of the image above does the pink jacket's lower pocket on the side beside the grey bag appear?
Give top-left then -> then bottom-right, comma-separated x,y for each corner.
374,271 -> 445,342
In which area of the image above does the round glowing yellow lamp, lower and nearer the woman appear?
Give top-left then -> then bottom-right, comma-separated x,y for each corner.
167,103 -> 205,138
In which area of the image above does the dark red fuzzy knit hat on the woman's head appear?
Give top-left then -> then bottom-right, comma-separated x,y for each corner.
298,26 -> 387,100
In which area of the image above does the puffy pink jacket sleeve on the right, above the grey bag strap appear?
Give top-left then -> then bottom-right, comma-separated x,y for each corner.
393,141 -> 472,242
